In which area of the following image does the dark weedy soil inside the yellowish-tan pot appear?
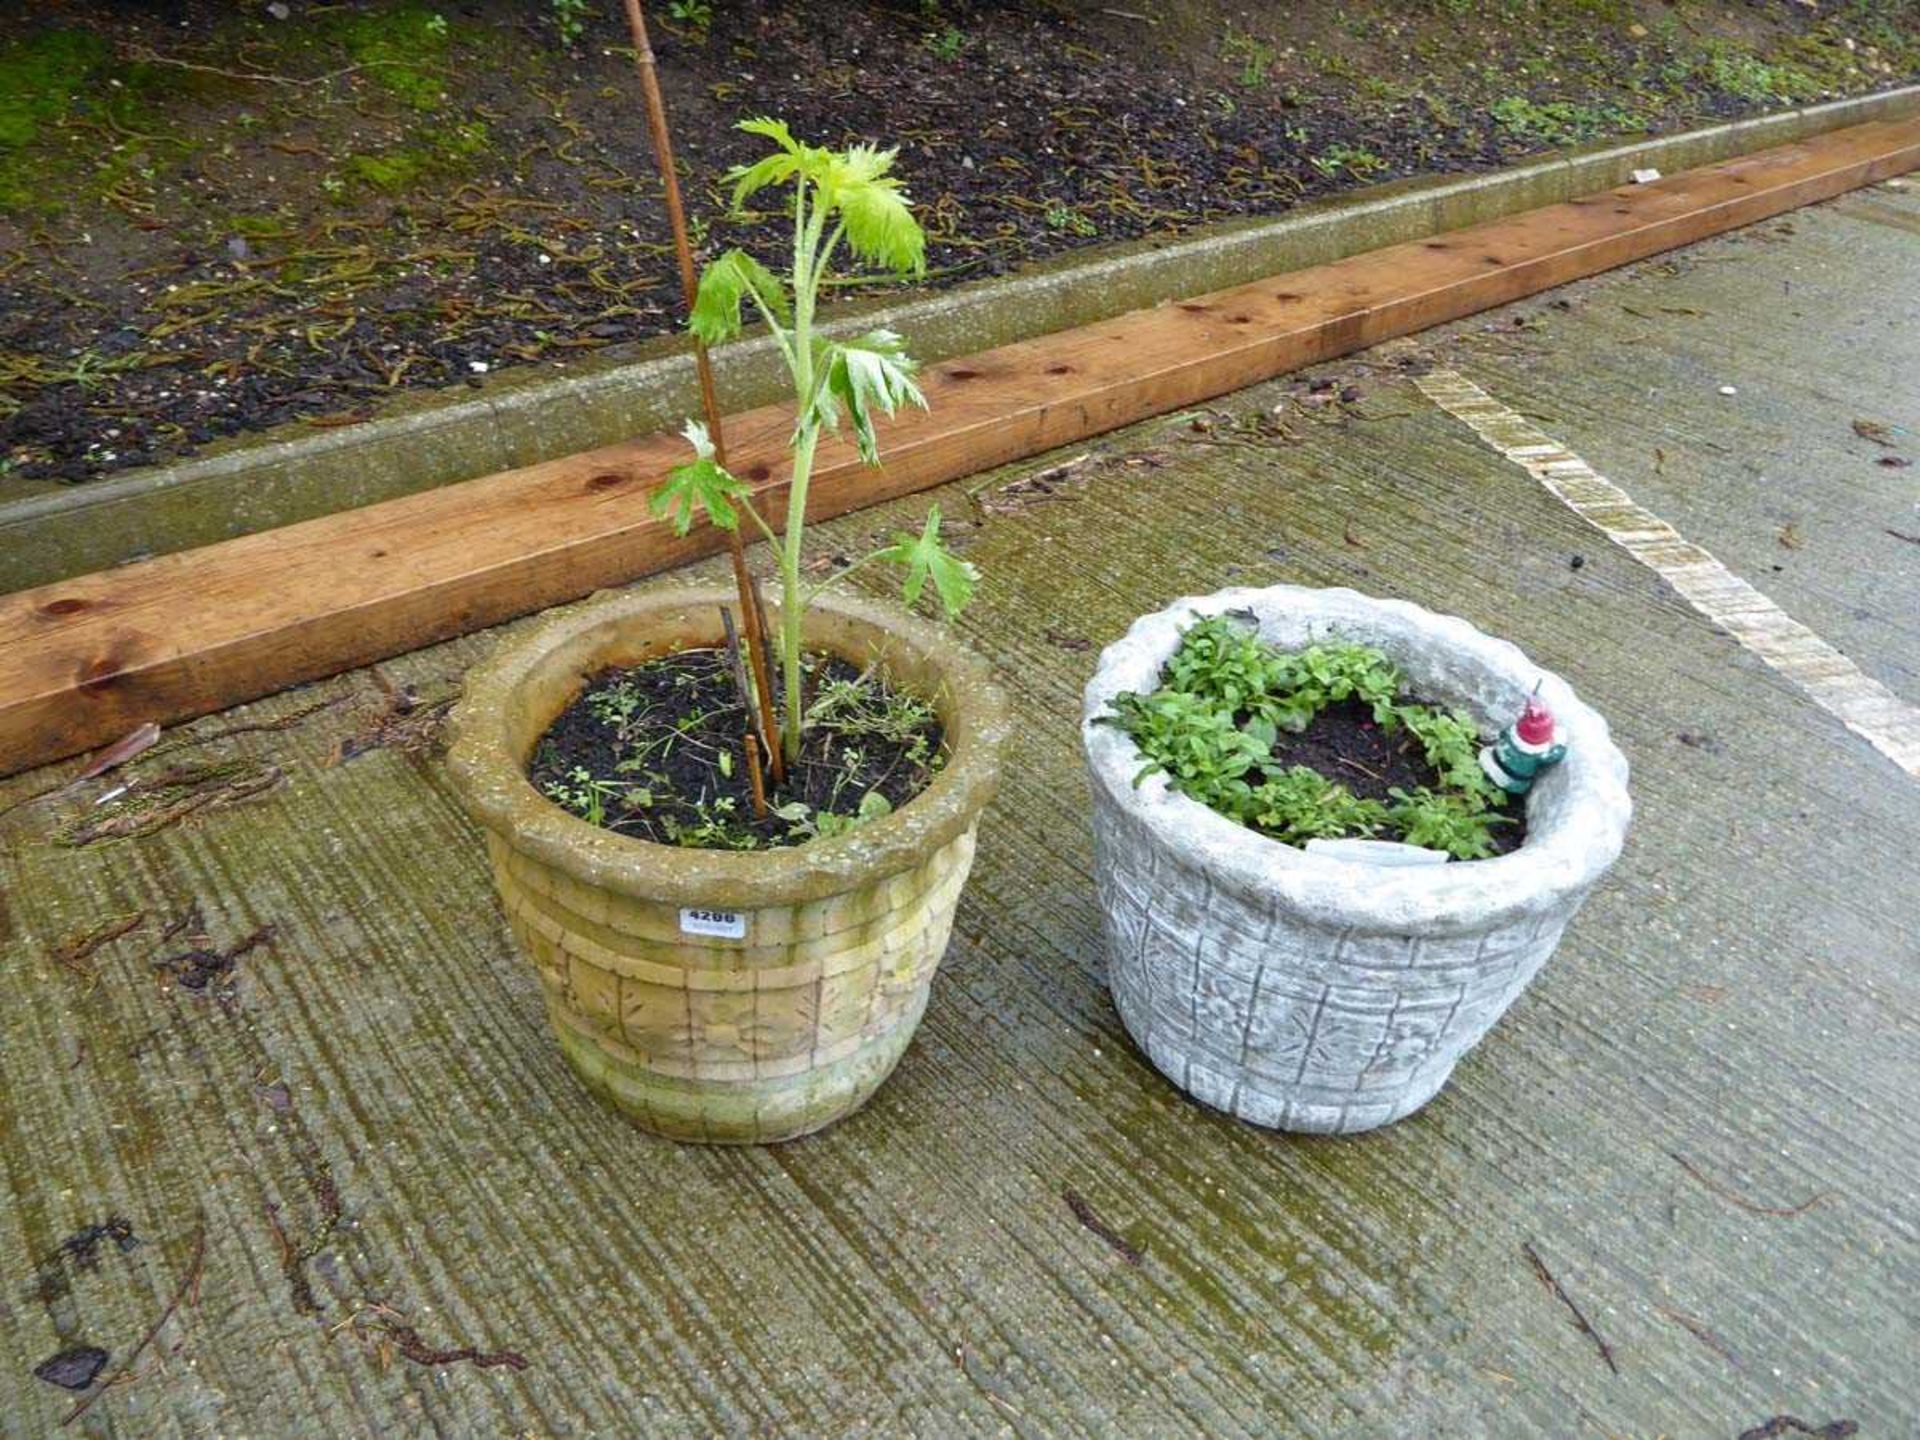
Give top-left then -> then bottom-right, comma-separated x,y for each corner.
528,649 -> 945,851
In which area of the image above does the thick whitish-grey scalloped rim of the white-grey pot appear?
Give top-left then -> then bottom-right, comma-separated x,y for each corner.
1081,586 -> 1632,935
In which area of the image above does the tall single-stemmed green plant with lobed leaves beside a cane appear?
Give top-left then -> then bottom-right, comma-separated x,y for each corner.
651,119 -> 979,764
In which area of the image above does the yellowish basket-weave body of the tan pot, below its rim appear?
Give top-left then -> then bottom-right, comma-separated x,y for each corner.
490,829 -> 973,1142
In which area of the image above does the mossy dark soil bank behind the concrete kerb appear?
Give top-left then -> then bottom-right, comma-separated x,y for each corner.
0,0 -> 1920,482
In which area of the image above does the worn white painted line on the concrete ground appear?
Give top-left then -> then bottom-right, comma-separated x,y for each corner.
1415,371 -> 1920,780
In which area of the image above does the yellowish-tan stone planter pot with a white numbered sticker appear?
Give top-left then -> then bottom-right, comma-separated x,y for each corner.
447,588 -> 1006,1144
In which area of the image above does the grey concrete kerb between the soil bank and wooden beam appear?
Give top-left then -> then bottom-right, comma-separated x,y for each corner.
0,86 -> 1920,593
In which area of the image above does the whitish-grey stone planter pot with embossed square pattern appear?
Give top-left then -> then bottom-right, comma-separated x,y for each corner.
1083,586 -> 1632,1133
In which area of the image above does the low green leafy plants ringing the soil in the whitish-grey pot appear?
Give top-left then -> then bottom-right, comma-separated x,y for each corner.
1106,616 -> 1526,860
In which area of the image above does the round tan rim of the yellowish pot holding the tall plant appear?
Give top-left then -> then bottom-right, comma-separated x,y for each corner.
447,586 -> 1008,910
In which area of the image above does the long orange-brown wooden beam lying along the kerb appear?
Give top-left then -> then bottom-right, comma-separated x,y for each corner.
0,119 -> 1920,774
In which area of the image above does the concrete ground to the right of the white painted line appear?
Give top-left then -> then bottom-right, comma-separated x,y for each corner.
1443,180 -> 1920,705
